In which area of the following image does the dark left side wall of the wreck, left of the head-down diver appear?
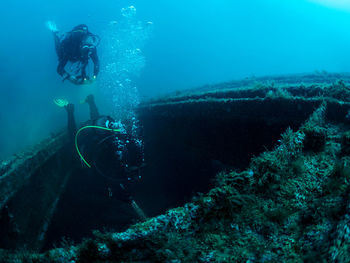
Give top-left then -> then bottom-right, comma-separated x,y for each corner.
0,134 -> 69,249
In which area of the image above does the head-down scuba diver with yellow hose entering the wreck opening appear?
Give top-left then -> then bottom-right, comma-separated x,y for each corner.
54,95 -> 147,220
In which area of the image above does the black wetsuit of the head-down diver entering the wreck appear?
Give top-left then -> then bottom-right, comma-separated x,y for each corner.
67,98 -> 142,202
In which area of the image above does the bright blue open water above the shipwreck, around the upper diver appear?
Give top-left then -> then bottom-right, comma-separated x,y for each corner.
0,0 -> 350,159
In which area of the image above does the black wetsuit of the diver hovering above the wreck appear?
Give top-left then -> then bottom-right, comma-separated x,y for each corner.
54,25 -> 100,81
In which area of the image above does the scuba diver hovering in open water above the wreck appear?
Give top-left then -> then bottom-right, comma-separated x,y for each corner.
47,21 -> 100,85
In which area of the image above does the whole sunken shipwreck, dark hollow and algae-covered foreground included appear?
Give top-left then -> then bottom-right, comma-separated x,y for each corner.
0,72 -> 350,263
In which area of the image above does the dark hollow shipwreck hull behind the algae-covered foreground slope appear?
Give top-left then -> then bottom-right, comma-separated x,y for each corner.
0,75 -> 350,260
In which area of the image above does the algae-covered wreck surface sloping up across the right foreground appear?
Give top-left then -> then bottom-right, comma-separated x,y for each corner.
0,76 -> 350,263
